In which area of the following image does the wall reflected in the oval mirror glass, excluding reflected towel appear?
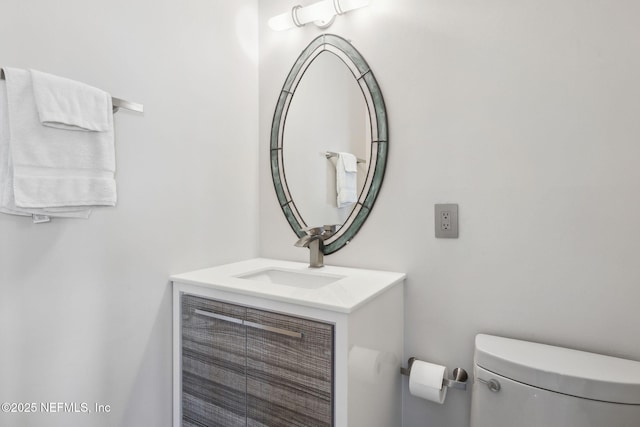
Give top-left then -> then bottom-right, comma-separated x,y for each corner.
283,52 -> 371,226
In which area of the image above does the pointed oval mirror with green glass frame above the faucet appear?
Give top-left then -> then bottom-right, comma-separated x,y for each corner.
271,34 -> 388,254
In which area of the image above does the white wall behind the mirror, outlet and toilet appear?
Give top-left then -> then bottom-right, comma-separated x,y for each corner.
260,0 -> 640,427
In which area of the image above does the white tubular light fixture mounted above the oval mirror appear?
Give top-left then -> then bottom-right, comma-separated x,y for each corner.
269,0 -> 369,31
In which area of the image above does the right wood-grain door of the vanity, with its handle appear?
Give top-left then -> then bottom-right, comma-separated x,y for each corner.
245,308 -> 334,427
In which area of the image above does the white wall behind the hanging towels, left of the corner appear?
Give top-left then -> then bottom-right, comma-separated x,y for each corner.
0,0 -> 258,427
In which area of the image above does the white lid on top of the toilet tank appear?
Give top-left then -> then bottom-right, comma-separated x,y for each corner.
475,334 -> 640,405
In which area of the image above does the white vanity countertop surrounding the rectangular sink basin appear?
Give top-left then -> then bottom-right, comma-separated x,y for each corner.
171,258 -> 406,313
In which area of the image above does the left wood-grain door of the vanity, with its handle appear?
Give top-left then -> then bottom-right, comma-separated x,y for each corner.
182,295 -> 247,427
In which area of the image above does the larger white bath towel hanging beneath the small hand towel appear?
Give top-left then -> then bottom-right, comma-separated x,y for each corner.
4,68 -> 116,211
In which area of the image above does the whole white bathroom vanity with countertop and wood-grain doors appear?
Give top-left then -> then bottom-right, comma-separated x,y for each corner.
171,258 -> 405,427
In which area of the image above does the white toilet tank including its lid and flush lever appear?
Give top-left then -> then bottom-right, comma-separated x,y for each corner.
471,334 -> 640,427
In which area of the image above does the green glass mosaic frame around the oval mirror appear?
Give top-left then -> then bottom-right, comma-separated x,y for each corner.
271,34 -> 389,255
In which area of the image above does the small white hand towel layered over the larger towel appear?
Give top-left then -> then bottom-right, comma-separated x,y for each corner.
29,70 -> 113,132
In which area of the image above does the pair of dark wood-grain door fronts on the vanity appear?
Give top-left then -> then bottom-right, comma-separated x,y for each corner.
181,294 -> 334,427
